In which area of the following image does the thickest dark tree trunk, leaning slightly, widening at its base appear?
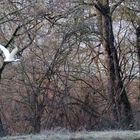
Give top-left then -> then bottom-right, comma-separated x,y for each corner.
100,0 -> 134,129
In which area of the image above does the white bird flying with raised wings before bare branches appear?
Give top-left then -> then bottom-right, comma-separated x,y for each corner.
0,44 -> 20,62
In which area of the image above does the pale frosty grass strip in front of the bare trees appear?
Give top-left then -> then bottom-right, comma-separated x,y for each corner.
0,131 -> 140,140
